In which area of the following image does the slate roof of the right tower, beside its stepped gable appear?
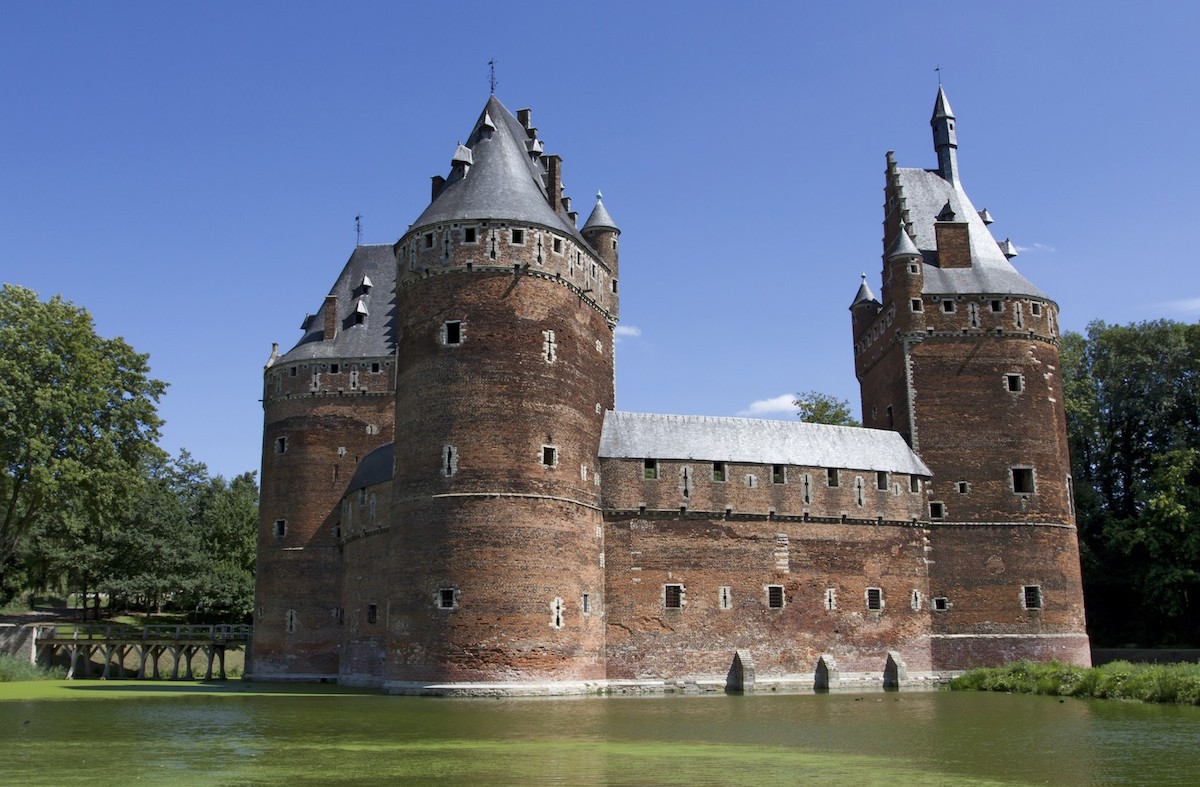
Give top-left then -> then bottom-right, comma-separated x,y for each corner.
896,167 -> 1049,300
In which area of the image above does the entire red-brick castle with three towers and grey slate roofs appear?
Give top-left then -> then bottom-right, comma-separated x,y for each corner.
247,88 -> 1090,693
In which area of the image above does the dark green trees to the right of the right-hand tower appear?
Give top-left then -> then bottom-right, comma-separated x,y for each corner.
1061,320 -> 1200,644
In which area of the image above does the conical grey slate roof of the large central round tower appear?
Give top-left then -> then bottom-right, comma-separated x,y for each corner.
413,96 -> 587,245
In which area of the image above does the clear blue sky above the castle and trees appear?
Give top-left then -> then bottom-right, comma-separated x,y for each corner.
0,0 -> 1200,476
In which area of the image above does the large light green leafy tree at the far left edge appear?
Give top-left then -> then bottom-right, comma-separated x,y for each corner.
0,284 -> 166,599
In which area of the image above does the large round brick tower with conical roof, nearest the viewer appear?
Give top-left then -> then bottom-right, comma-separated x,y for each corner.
383,97 -> 618,691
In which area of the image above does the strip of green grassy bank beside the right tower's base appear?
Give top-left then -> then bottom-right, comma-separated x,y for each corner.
950,661 -> 1200,705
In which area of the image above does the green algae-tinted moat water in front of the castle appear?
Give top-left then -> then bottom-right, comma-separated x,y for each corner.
0,681 -> 1200,786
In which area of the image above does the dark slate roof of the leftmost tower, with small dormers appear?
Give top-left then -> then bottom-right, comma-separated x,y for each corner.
275,244 -> 396,364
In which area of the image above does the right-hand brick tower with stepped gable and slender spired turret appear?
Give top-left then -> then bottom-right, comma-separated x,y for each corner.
851,88 -> 1090,669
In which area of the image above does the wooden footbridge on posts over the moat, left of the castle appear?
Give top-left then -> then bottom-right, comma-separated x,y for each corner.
34,623 -> 254,680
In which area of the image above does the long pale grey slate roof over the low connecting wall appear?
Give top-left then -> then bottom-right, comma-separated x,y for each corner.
600,410 -> 932,476
